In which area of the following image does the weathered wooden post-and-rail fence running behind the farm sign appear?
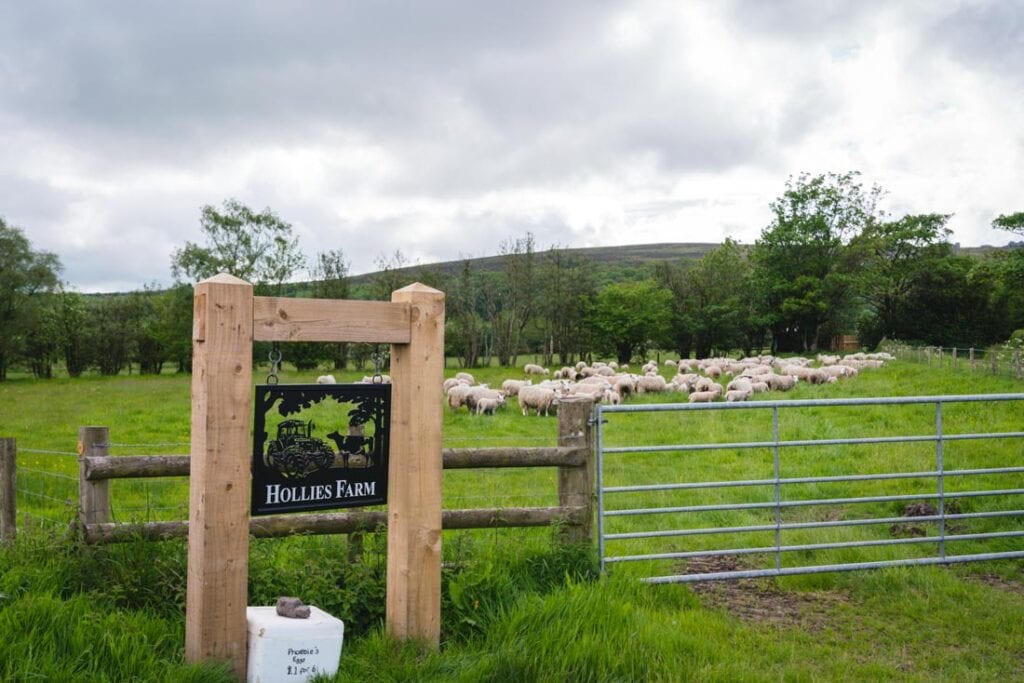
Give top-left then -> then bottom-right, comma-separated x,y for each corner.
79,398 -> 595,544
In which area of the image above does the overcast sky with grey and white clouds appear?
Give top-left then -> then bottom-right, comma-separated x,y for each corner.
0,0 -> 1024,292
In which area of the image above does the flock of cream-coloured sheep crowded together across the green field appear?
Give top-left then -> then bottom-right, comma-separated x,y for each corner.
443,353 -> 893,415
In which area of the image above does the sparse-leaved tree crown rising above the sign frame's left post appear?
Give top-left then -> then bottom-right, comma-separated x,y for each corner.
171,199 -> 305,295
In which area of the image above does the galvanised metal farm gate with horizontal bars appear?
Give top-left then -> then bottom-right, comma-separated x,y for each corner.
597,394 -> 1024,583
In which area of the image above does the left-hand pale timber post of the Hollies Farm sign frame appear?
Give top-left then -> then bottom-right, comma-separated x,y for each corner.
185,273 -> 253,679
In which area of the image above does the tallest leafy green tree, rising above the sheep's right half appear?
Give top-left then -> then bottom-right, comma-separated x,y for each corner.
754,172 -> 882,351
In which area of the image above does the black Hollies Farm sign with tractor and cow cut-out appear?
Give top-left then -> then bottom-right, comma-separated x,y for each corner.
252,384 -> 391,515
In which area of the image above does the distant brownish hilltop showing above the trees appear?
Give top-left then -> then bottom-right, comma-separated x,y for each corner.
349,242 -> 721,286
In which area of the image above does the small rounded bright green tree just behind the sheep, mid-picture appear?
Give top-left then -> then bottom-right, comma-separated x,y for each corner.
588,280 -> 672,362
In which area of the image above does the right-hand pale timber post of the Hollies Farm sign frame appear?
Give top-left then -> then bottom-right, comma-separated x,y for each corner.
385,283 -> 444,648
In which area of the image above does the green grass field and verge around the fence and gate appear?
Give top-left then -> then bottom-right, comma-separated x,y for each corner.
0,362 -> 1024,681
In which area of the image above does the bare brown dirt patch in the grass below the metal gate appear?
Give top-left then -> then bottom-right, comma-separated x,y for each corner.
682,556 -> 850,632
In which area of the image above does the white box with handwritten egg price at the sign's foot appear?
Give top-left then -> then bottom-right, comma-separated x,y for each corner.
246,605 -> 345,683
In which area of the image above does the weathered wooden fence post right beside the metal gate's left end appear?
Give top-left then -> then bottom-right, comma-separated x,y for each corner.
558,396 -> 595,543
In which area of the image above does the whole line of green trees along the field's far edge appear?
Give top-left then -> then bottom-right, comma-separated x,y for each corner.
0,172 -> 1024,380
